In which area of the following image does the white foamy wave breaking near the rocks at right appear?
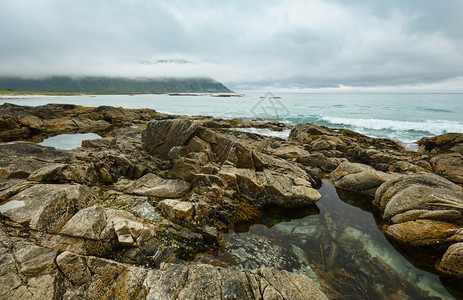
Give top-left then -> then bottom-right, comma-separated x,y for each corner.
320,116 -> 463,135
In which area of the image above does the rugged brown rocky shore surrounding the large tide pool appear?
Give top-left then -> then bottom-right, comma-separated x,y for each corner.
0,104 -> 463,299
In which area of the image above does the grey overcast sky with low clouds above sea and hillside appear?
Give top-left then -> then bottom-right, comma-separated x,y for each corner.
0,0 -> 463,91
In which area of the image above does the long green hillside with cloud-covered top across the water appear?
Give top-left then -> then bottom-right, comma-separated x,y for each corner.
0,77 -> 232,94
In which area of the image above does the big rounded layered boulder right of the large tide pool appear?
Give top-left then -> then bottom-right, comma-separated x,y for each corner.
375,173 -> 463,262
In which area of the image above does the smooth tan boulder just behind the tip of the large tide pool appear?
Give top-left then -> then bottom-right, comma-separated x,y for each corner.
331,161 -> 395,196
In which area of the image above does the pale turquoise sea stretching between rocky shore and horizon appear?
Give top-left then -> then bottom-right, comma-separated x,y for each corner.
0,93 -> 463,143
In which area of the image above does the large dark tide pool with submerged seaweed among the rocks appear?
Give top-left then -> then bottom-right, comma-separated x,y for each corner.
200,180 -> 459,299
